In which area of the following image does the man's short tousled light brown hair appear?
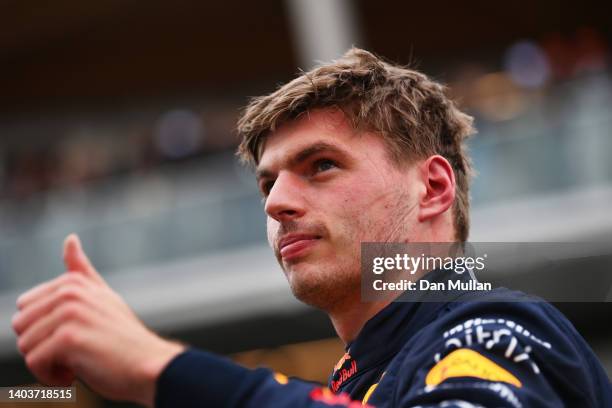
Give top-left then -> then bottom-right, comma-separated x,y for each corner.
237,48 -> 474,242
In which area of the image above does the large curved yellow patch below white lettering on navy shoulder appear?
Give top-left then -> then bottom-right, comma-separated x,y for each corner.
425,349 -> 522,388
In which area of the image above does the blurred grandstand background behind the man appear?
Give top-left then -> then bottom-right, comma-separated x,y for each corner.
0,0 -> 612,407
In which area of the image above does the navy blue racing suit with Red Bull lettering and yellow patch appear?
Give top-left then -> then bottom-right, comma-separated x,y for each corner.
155,270 -> 612,408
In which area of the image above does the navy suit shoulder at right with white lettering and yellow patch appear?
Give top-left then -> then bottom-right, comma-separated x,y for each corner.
376,289 -> 610,406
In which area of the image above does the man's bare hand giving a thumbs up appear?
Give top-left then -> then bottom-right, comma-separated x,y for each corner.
13,235 -> 184,406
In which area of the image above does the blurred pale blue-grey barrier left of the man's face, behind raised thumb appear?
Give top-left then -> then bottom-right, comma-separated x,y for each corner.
0,153 -> 265,290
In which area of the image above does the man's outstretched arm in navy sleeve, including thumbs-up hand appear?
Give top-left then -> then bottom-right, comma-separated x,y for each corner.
12,236 -> 372,408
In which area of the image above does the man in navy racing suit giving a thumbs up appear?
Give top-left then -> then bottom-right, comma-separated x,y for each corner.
13,49 -> 612,407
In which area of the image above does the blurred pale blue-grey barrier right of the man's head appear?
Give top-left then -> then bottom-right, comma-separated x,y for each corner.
470,75 -> 612,206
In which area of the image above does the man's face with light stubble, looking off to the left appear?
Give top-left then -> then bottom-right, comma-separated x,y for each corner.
257,109 -> 422,311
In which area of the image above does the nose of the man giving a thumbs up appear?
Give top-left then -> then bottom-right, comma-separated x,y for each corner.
265,172 -> 306,222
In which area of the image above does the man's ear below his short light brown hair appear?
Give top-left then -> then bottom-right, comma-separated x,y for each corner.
418,155 -> 455,222
